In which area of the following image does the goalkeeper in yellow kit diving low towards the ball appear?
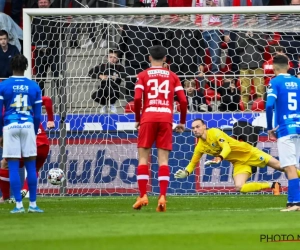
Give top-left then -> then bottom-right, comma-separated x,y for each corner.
175,119 -> 300,195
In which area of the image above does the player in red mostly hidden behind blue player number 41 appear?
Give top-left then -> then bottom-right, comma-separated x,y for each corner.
0,96 -> 54,203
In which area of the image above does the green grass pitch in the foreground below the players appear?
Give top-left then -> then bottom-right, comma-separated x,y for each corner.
0,195 -> 300,250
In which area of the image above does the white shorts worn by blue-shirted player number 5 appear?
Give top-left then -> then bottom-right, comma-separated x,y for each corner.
277,134 -> 300,168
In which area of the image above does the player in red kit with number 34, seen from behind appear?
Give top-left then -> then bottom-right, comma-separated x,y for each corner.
133,46 -> 187,212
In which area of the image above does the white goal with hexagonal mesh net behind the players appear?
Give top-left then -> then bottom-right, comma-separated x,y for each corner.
19,7 -> 300,195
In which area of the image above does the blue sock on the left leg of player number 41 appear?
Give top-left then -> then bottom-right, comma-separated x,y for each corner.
7,159 -> 22,202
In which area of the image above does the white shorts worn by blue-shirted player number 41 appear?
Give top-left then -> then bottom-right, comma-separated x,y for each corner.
2,122 -> 37,158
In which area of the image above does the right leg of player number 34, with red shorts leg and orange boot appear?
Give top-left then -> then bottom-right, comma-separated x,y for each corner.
156,122 -> 172,212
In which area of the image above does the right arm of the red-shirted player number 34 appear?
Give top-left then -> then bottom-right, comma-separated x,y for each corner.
174,74 -> 187,132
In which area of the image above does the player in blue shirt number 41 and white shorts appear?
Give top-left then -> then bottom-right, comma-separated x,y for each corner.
0,55 -> 43,213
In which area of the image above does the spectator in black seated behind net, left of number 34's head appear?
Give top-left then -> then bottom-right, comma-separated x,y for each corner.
89,50 -> 124,114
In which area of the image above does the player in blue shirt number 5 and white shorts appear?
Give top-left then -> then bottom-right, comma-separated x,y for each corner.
266,55 -> 300,212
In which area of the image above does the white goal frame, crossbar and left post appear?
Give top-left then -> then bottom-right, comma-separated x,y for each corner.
23,6 -> 300,79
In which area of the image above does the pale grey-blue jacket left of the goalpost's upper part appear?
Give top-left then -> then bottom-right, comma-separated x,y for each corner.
0,13 -> 23,51
